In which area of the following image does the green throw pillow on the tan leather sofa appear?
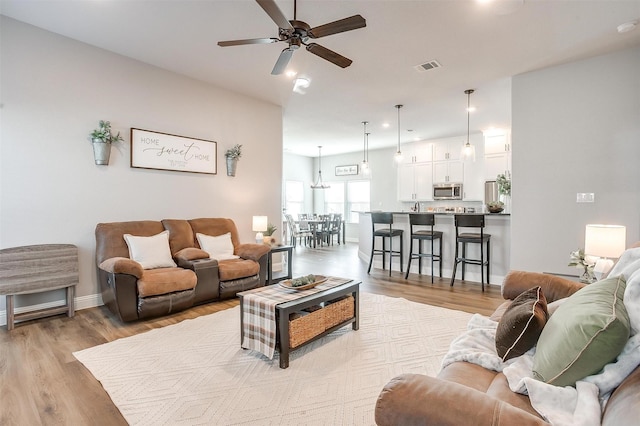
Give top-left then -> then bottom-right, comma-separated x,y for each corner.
533,276 -> 629,386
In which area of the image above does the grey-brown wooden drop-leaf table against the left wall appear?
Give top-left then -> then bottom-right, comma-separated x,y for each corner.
0,244 -> 78,330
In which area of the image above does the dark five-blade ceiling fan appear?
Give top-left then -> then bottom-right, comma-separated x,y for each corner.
218,0 -> 367,75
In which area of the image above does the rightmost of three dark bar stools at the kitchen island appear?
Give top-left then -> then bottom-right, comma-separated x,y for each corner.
451,214 -> 491,291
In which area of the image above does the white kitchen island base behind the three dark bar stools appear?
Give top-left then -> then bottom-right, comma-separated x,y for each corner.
358,212 -> 511,285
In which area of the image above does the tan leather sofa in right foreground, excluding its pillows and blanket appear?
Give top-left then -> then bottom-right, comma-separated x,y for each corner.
375,271 -> 640,426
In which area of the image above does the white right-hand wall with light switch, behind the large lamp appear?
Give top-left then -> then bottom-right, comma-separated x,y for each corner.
511,48 -> 640,274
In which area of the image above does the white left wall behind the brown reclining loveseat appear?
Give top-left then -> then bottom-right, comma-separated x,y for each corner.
0,16 -> 282,315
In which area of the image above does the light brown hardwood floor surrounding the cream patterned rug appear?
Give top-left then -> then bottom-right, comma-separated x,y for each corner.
0,244 -> 503,426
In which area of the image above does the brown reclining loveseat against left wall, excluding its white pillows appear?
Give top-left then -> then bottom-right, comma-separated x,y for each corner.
95,218 -> 270,321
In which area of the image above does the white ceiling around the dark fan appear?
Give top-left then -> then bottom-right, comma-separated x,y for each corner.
0,0 -> 640,156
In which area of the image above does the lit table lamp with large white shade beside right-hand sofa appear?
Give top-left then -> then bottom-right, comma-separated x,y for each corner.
584,225 -> 627,279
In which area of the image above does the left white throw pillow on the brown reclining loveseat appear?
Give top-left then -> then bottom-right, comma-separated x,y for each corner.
124,231 -> 177,269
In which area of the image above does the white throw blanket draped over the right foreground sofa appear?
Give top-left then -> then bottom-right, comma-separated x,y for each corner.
442,248 -> 640,426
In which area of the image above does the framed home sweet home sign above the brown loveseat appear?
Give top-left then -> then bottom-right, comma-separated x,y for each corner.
131,129 -> 218,175
